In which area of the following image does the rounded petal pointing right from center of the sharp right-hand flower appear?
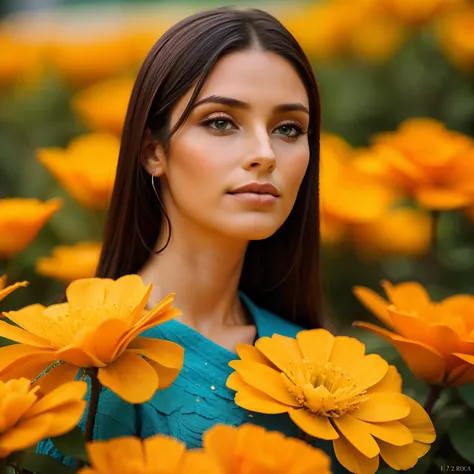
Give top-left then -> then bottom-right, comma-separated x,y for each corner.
353,392 -> 410,423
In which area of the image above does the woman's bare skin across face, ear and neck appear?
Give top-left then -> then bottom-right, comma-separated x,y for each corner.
141,50 -> 309,350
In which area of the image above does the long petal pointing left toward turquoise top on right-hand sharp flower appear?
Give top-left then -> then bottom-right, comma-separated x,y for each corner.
229,360 -> 300,407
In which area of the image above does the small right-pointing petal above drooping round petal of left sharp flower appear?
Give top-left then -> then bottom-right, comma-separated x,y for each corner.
127,337 -> 184,370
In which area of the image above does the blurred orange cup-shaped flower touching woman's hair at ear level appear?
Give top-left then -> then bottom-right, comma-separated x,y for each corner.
37,133 -> 120,210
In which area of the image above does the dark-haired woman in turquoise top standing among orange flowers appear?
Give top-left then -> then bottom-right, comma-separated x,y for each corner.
38,7 -> 335,470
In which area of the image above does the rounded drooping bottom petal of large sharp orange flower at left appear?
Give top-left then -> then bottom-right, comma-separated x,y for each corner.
98,351 -> 159,404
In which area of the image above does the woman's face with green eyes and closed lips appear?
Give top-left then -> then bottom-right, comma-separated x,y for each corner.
152,51 -> 309,240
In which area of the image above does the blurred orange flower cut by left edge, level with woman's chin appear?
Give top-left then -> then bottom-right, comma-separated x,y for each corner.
0,198 -> 63,260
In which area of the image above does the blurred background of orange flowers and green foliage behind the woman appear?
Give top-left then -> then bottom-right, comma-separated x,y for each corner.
0,0 -> 474,472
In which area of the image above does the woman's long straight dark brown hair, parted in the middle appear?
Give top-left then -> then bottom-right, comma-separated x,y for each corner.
97,7 -> 322,328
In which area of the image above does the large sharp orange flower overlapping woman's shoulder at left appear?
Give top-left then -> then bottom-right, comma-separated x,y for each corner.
0,275 -> 184,403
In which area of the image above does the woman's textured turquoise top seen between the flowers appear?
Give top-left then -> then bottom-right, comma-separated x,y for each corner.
38,293 -> 345,473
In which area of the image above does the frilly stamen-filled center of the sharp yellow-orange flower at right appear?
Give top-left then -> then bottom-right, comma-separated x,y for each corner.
281,359 -> 368,418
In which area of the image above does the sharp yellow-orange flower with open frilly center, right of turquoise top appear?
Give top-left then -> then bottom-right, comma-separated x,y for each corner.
227,329 -> 435,474
